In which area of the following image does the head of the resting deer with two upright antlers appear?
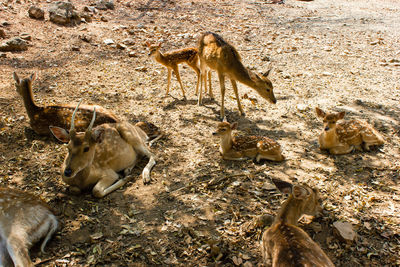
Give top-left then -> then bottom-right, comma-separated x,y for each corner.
50,102 -> 103,179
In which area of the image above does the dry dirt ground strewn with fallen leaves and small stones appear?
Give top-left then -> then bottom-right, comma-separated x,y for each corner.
0,0 -> 400,267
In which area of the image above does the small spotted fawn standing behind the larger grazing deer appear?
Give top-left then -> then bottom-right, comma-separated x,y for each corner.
146,42 -> 200,98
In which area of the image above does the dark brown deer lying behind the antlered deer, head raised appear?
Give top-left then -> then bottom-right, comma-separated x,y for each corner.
13,72 -> 118,135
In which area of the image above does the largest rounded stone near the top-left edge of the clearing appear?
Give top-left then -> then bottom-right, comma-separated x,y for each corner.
49,1 -> 81,25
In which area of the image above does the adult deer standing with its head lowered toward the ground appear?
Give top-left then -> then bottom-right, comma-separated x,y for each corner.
198,32 -> 276,120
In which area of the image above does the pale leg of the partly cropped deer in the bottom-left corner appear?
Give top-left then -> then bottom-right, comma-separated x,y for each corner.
6,237 -> 33,267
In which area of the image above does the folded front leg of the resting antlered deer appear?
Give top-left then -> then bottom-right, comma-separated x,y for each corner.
92,169 -> 126,198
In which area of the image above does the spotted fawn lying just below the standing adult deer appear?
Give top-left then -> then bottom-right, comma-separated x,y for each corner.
213,122 -> 285,162
